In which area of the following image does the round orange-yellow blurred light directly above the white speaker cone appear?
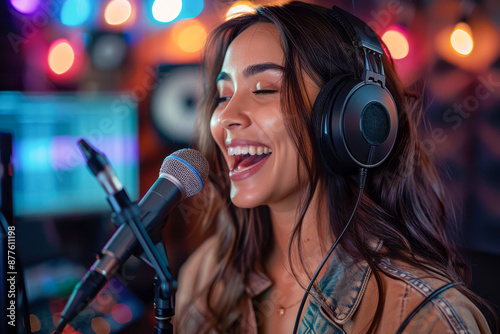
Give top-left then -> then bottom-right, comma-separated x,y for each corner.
173,20 -> 207,53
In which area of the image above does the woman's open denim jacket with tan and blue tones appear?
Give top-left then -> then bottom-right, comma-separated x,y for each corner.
174,239 -> 491,334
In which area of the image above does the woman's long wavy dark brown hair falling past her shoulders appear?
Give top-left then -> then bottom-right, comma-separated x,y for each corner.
179,2 -> 488,333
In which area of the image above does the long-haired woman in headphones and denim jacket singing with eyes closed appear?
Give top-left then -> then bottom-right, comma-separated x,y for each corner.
175,2 -> 490,334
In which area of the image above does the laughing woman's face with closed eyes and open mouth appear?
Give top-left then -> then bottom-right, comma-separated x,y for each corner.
211,23 -> 319,209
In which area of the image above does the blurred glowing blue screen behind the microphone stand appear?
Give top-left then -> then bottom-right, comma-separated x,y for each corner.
0,92 -> 139,216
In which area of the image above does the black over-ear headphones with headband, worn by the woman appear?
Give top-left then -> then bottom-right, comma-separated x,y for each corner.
313,6 -> 398,173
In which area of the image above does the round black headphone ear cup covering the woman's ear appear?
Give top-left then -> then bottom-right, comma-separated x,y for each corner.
313,76 -> 397,173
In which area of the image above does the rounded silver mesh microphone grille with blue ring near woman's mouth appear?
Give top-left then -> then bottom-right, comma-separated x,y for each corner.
160,148 -> 208,197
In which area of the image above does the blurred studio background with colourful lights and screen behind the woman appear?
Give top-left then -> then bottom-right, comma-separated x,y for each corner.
0,0 -> 500,334
